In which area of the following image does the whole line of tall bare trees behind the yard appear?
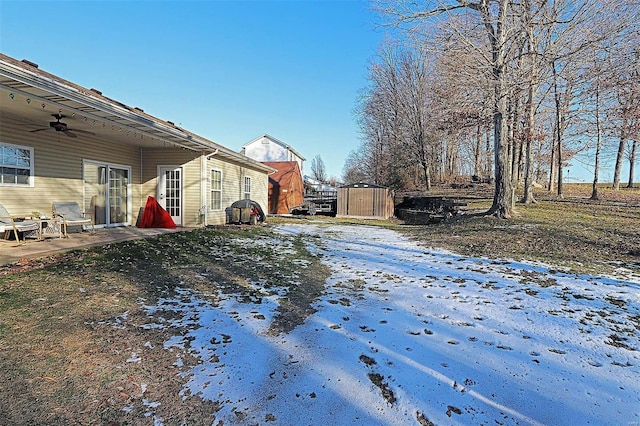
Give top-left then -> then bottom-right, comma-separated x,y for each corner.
343,0 -> 640,218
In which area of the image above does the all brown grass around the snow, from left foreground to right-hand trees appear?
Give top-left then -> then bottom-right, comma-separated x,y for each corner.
0,185 -> 640,425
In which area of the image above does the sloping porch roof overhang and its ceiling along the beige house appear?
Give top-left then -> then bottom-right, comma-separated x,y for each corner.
0,54 -> 271,171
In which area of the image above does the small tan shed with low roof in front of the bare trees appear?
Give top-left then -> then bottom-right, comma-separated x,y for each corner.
336,183 -> 394,219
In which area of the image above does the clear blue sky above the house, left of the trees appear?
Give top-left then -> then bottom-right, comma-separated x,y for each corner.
0,0 -> 383,178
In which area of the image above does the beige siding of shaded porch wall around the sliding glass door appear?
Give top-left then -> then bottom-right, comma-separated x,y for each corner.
0,117 -> 140,223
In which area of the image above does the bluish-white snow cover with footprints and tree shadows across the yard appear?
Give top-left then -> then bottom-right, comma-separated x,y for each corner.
145,224 -> 640,425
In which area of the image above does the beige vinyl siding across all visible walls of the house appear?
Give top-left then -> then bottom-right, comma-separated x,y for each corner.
0,115 -> 268,226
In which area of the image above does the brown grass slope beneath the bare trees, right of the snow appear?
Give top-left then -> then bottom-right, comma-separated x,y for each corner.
400,184 -> 640,273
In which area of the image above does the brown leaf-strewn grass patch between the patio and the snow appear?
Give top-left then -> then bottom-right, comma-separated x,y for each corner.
0,227 -> 327,425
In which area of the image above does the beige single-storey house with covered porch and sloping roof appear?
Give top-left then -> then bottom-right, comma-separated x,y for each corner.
0,54 -> 273,227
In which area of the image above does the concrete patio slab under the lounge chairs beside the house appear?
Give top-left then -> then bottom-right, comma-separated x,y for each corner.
0,226 -> 192,265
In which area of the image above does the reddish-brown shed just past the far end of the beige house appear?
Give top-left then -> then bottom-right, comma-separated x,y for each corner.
264,161 -> 304,214
